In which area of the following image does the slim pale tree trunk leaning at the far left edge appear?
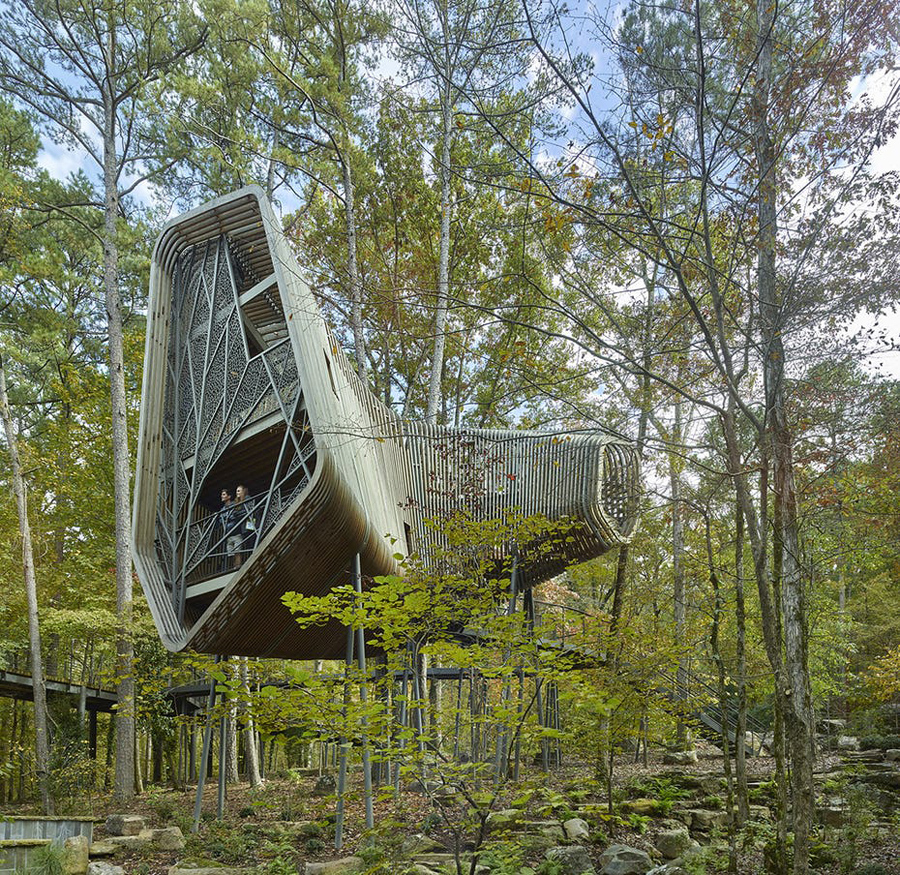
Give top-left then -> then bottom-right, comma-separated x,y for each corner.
0,358 -> 53,815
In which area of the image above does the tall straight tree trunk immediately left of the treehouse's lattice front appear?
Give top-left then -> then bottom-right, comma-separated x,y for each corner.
103,89 -> 135,802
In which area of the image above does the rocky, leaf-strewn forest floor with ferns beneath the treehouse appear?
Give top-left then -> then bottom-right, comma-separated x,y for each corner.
1,746 -> 900,875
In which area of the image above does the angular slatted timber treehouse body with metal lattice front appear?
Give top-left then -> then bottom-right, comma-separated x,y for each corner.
133,187 -> 639,658
